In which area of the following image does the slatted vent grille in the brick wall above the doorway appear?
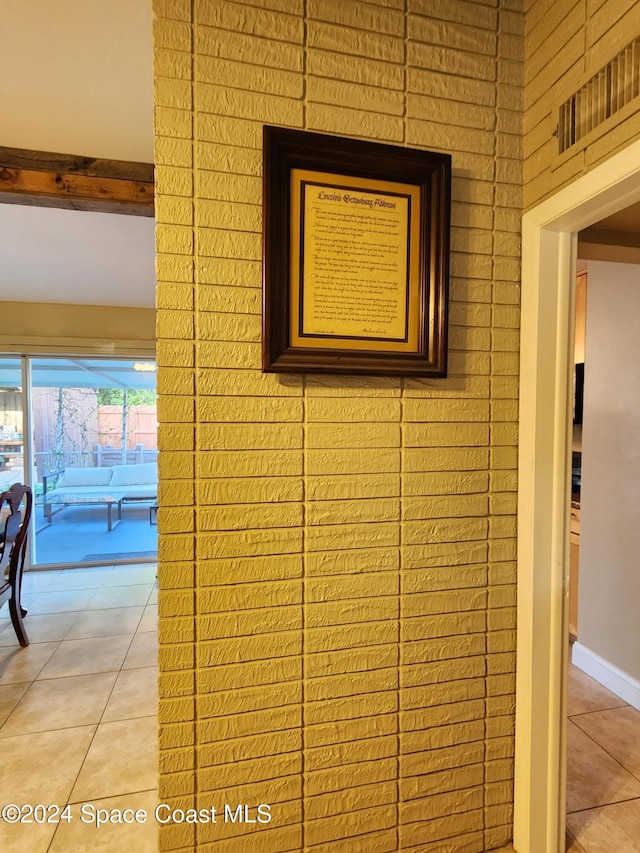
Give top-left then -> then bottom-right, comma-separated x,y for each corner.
558,38 -> 640,154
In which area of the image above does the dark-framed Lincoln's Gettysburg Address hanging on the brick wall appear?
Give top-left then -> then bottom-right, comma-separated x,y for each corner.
262,126 -> 451,377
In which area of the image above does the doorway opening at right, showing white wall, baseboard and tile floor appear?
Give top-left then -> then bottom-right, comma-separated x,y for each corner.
566,251 -> 640,853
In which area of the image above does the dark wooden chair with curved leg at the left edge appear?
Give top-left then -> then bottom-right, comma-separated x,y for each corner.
0,483 -> 33,646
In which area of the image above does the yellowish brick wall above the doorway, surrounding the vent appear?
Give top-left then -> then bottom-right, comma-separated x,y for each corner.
524,0 -> 640,208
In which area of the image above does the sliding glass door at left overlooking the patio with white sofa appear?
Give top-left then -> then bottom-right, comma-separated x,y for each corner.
0,357 -> 158,567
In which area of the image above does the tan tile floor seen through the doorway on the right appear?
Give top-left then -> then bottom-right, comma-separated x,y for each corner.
564,665 -> 640,853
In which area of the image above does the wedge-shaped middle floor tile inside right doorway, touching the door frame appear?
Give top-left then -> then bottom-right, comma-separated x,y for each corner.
567,720 -> 640,812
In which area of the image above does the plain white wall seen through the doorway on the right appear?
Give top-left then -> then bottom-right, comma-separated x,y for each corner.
578,261 -> 640,681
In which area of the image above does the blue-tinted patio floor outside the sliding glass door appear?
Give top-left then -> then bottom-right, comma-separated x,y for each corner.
35,503 -> 158,566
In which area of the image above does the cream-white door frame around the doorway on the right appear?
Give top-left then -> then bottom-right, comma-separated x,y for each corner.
514,141 -> 640,853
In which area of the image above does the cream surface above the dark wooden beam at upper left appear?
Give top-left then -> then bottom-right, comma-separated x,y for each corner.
0,0 -> 153,163
